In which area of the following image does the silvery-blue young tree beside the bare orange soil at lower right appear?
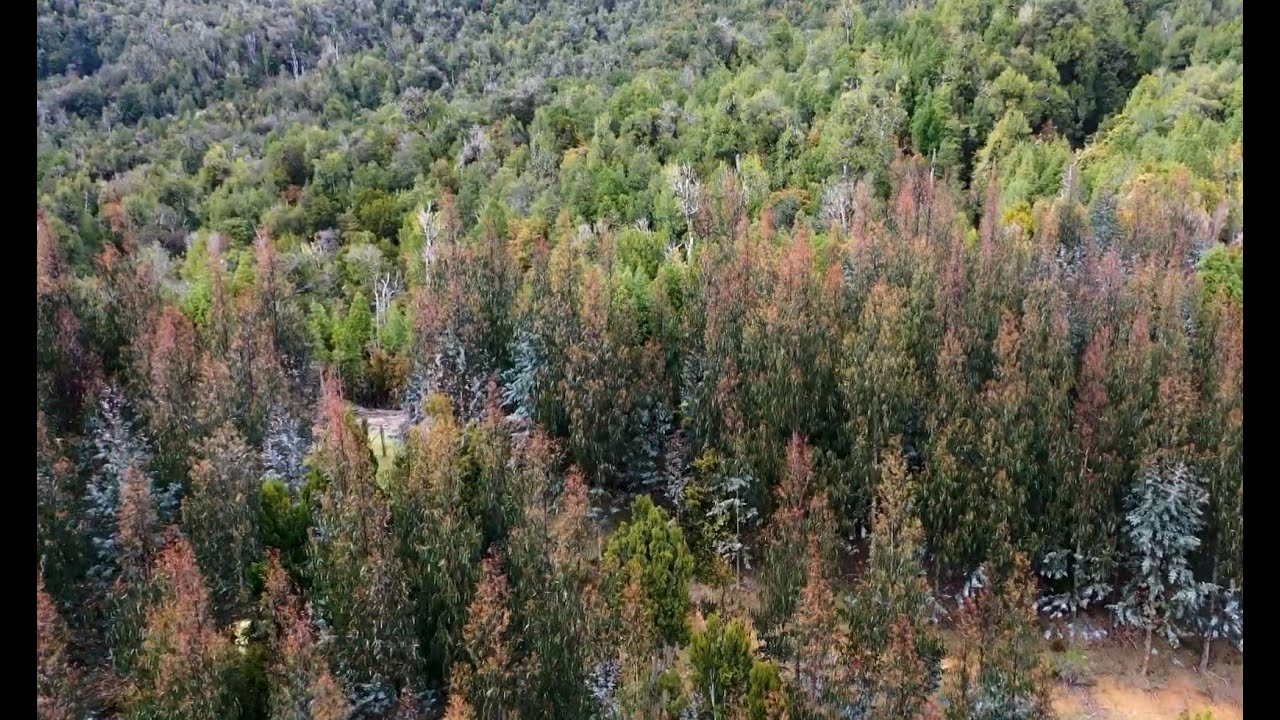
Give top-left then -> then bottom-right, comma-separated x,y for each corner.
1111,464 -> 1207,675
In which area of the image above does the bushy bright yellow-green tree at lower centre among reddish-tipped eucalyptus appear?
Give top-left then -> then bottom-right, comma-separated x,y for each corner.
604,495 -> 694,644
